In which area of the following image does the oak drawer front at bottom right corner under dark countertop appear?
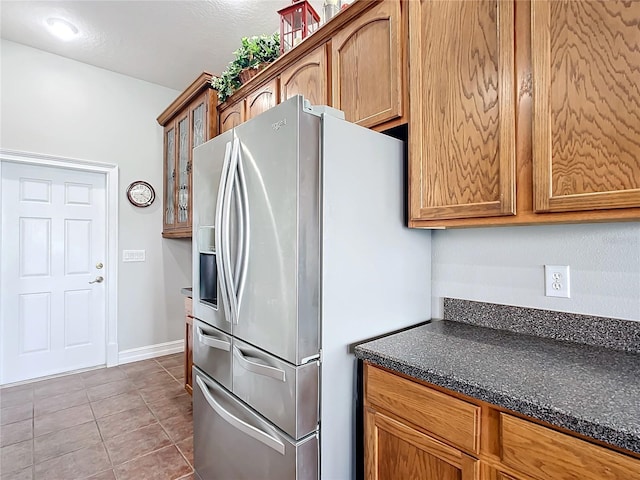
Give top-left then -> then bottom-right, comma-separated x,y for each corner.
500,413 -> 640,480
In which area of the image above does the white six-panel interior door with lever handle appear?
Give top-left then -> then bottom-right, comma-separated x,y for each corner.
0,162 -> 108,384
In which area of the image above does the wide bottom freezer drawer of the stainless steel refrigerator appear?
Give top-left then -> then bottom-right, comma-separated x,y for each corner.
193,368 -> 318,480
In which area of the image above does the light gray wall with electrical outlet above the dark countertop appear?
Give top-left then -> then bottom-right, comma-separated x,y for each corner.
431,222 -> 640,321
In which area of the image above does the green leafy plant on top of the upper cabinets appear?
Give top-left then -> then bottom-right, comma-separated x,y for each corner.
211,33 -> 280,102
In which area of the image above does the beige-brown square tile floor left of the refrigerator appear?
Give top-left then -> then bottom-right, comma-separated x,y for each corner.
0,354 -> 195,480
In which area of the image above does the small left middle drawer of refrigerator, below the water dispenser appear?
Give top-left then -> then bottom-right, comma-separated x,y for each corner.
193,319 -> 232,390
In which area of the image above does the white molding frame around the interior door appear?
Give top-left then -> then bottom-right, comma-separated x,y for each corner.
0,148 -> 118,367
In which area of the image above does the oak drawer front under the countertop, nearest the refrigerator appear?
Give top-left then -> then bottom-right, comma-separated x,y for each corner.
366,365 -> 480,453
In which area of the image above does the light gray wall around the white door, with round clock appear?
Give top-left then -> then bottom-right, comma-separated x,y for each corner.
0,40 -> 191,351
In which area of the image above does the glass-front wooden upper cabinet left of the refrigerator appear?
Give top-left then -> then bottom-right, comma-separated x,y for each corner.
158,72 -> 217,238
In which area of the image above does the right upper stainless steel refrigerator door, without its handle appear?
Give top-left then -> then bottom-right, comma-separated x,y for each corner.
233,96 -> 320,364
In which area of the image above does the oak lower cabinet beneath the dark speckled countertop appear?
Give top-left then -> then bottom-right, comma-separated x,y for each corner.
364,364 -> 640,480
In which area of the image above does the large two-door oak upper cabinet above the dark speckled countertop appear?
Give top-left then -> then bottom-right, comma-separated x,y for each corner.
408,0 -> 640,228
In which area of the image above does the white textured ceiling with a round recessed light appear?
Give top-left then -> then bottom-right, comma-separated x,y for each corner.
0,0 -> 322,90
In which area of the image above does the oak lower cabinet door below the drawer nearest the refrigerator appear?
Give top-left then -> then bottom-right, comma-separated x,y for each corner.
365,409 -> 480,480
